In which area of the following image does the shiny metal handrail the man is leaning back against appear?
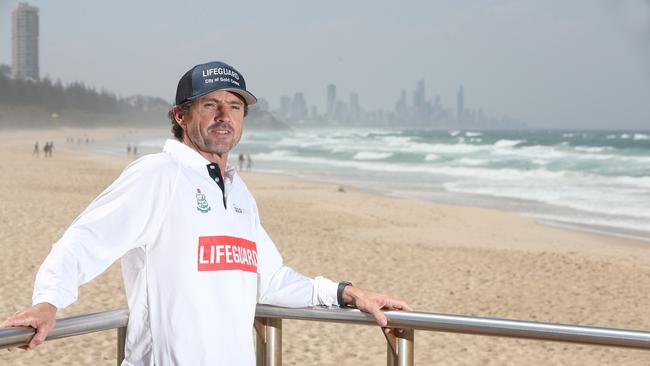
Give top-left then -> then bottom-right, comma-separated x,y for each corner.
0,305 -> 650,364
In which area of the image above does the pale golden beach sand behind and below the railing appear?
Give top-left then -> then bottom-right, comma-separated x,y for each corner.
0,130 -> 650,366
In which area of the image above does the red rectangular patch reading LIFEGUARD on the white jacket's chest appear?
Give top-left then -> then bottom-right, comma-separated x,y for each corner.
197,236 -> 257,272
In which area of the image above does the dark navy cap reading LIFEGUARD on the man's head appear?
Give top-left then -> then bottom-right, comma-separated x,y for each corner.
176,61 -> 257,105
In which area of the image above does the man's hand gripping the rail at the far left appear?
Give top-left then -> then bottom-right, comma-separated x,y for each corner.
0,302 -> 57,350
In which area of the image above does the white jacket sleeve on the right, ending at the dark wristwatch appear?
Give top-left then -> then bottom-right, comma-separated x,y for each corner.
255,202 -> 338,307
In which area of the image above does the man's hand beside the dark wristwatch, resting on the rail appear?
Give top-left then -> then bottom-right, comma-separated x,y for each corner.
343,286 -> 413,333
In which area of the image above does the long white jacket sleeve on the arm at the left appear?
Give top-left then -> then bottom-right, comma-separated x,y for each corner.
32,157 -> 175,309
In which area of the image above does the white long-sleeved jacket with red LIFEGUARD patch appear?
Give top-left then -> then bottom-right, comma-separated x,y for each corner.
33,140 -> 337,366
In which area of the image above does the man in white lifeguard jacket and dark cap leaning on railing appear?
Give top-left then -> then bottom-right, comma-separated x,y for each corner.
2,62 -> 409,365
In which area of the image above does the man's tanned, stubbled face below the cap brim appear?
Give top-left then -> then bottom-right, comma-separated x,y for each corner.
180,90 -> 244,155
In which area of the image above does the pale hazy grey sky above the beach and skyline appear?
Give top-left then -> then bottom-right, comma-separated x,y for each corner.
0,0 -> 650,129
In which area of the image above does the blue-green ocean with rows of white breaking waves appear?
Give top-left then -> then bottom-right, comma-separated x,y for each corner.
73,129 -> 650,240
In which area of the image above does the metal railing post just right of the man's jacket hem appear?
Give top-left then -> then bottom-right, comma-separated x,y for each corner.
255,318 -> 282,366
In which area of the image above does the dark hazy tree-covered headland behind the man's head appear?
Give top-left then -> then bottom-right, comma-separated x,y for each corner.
0,72 -> 289,129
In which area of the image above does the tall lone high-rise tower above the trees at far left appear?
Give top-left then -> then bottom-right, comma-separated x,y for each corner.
11,3 -> 39,80
